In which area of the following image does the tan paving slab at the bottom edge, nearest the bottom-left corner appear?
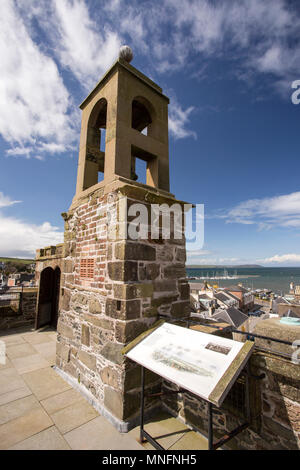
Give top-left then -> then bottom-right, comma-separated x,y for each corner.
9,426 -> 70,450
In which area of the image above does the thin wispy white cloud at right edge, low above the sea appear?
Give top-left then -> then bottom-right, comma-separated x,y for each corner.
216,191 -> 300,229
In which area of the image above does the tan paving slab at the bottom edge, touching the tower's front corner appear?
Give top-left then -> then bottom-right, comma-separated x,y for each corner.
64,416 -> 144,450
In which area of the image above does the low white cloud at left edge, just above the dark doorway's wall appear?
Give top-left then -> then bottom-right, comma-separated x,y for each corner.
0,213 -> 63,258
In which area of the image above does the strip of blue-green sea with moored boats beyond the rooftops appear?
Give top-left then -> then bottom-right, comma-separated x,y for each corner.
186,267 -> 300,295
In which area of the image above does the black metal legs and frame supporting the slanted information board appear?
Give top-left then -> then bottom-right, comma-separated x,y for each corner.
140,364 -> 263,450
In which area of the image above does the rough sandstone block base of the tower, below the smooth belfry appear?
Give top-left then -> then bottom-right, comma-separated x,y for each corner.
57,185 -> 189,421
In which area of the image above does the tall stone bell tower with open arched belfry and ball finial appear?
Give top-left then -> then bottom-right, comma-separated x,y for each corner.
57,46 -> 189,431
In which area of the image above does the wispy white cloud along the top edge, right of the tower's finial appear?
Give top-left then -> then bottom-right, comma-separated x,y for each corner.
102,0 -> 300,92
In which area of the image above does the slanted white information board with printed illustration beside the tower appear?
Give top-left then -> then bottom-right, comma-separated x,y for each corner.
126,323 -> 254,406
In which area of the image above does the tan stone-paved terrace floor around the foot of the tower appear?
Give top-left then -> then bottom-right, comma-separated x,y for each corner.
0,329 -> 207,450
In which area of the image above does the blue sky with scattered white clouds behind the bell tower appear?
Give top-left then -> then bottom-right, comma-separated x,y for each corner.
0,0 -> 300,266
